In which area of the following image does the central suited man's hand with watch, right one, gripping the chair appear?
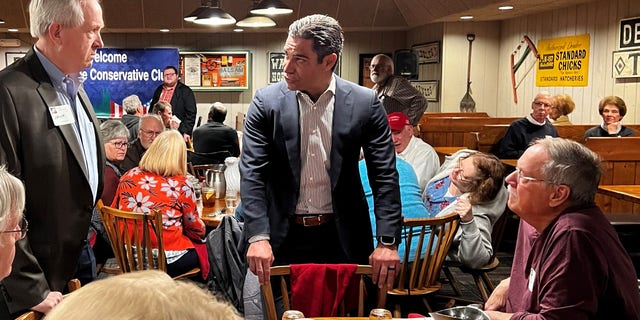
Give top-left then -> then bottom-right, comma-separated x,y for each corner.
369,245 -> 400,289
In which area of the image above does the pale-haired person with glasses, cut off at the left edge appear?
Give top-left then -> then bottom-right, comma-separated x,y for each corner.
0,166 -> 27,280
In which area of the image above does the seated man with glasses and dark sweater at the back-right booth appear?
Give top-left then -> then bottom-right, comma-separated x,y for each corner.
495,91 -> 558,159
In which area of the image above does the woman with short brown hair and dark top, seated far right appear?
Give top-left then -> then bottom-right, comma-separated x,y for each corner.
584,96 -> 634,140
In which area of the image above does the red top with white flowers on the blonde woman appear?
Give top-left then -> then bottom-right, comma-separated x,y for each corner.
112,167 -> 205,251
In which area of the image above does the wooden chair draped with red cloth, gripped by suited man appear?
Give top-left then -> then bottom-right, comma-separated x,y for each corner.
261,265 -> 386,320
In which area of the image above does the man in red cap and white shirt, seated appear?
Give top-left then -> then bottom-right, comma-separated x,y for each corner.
387,112 -> 440,192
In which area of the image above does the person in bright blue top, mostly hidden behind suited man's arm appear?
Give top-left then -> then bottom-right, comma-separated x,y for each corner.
358,158 -> 428,261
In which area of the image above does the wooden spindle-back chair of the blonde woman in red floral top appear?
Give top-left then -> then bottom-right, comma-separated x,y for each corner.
97,201 -> 200,279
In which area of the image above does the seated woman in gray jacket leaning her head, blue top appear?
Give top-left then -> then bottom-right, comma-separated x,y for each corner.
423,149 -> 508,268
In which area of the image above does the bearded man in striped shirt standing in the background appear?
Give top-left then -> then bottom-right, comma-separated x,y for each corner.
369,54 -> 427,127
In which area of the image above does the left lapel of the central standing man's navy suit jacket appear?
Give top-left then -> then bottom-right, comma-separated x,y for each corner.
278,86 -> 301,187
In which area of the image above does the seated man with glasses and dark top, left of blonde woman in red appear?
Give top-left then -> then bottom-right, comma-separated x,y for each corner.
119,114 -> 164,174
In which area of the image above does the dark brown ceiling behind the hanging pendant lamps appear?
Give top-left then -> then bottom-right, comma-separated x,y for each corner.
0,0 -> 593,33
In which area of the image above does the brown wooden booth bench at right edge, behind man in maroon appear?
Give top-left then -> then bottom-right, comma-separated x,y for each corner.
585,137 -> 640,214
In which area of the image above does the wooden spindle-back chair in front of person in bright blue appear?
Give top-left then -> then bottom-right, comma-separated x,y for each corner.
387,213 -> 460,318
